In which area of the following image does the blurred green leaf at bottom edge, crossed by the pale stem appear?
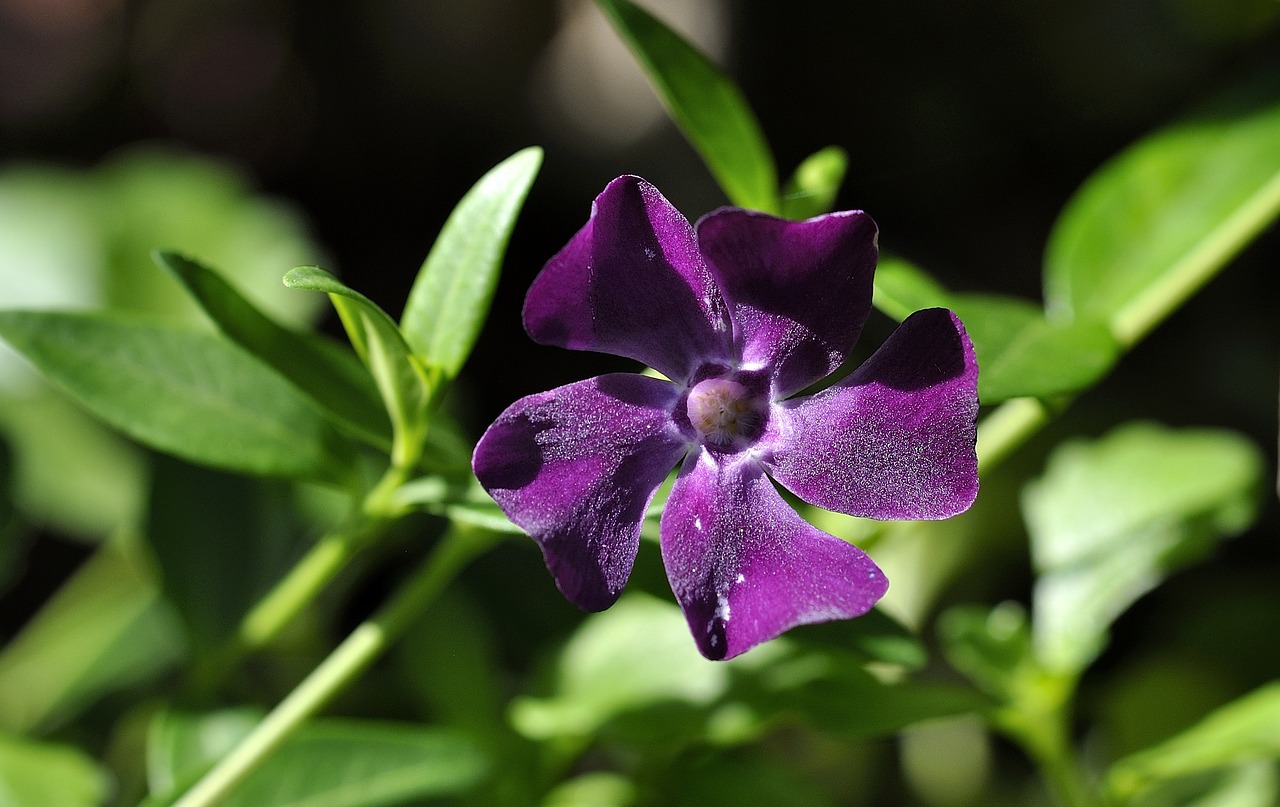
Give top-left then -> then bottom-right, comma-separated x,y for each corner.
145,710 -> 489,807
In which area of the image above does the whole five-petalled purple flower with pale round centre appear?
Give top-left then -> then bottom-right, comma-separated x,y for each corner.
474,177 -> 978,658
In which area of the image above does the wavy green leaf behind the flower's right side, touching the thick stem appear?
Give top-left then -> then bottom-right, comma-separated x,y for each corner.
874,257 -> 1119,404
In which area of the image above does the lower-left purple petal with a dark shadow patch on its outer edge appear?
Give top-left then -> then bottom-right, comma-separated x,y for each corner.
472,373 -> 686,611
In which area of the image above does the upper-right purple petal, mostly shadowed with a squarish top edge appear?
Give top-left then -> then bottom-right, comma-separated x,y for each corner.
698,208 -> 877,398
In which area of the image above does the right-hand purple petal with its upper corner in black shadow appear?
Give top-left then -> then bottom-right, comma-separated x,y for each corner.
760,309 -> 978,519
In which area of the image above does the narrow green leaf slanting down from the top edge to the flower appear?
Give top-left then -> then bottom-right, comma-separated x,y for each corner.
596,0 -> 780,214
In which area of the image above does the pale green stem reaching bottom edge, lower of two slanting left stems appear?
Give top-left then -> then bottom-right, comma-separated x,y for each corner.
174,526 -> 490,807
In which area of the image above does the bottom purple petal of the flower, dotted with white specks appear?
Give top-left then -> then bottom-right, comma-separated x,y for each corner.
662,451 -> 888,660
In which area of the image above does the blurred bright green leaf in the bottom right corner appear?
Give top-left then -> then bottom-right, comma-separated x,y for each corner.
1107,681 -> 1280,798
